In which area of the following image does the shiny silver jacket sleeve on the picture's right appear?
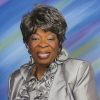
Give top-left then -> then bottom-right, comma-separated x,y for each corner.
73,62 -> 98,100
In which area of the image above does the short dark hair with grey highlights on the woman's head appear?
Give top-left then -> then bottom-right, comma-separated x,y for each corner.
20,5 -> 67,47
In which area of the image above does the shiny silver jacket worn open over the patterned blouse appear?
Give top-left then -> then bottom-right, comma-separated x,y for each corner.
8,49 -> 98,100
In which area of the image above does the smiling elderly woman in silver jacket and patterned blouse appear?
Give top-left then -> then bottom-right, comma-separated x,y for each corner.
9,5 -> 97,100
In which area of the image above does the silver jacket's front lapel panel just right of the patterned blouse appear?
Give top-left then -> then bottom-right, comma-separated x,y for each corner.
48,65 -> 74,100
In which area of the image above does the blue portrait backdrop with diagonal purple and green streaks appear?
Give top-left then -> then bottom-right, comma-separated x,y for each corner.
0,0 -> 100,100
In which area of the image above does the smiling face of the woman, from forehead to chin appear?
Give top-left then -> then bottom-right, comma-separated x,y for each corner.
28,28 -> 59,66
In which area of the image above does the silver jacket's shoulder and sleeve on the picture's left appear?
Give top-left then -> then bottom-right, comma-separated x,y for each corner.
8,64 -> 28,98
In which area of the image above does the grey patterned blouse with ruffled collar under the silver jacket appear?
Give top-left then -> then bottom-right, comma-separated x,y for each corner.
16,49 -> 68,100
